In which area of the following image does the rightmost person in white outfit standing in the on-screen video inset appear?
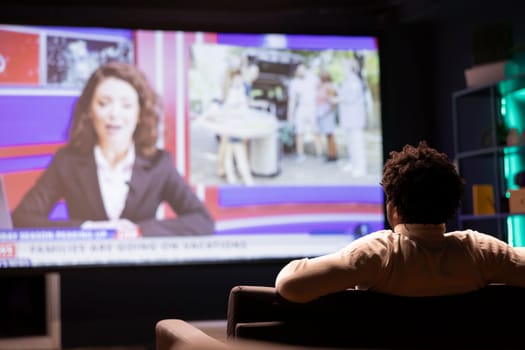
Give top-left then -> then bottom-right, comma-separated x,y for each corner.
338,58 -> 367,177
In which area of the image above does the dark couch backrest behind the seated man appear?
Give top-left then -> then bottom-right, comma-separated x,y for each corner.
227,284 -> 525,349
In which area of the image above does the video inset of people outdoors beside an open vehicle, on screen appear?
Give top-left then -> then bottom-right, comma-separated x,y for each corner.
190,45 -> 382,186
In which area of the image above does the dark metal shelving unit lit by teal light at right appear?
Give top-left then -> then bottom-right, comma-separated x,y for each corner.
452,75 -> 525,246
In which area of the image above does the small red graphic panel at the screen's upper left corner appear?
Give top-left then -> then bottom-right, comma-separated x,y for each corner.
0,29 -> 40,84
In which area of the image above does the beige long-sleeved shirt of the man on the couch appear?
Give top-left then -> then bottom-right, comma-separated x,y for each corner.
275,224 -> 525,302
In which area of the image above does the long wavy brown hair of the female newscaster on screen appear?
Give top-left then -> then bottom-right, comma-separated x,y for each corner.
68,61 -> 161,157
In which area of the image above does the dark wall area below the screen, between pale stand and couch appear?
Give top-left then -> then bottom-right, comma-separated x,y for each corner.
61,263 -> 282,348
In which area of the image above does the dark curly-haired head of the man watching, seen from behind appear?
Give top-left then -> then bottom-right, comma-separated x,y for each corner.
381,141 -> 465,224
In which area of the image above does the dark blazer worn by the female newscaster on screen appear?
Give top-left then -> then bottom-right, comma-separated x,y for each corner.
12,148 -> 215,236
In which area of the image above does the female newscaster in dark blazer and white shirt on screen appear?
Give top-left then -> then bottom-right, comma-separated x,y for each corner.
13,62 -> 214,238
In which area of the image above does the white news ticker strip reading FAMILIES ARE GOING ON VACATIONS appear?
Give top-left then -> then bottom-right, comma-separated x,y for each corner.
0,230 -> 354,268
